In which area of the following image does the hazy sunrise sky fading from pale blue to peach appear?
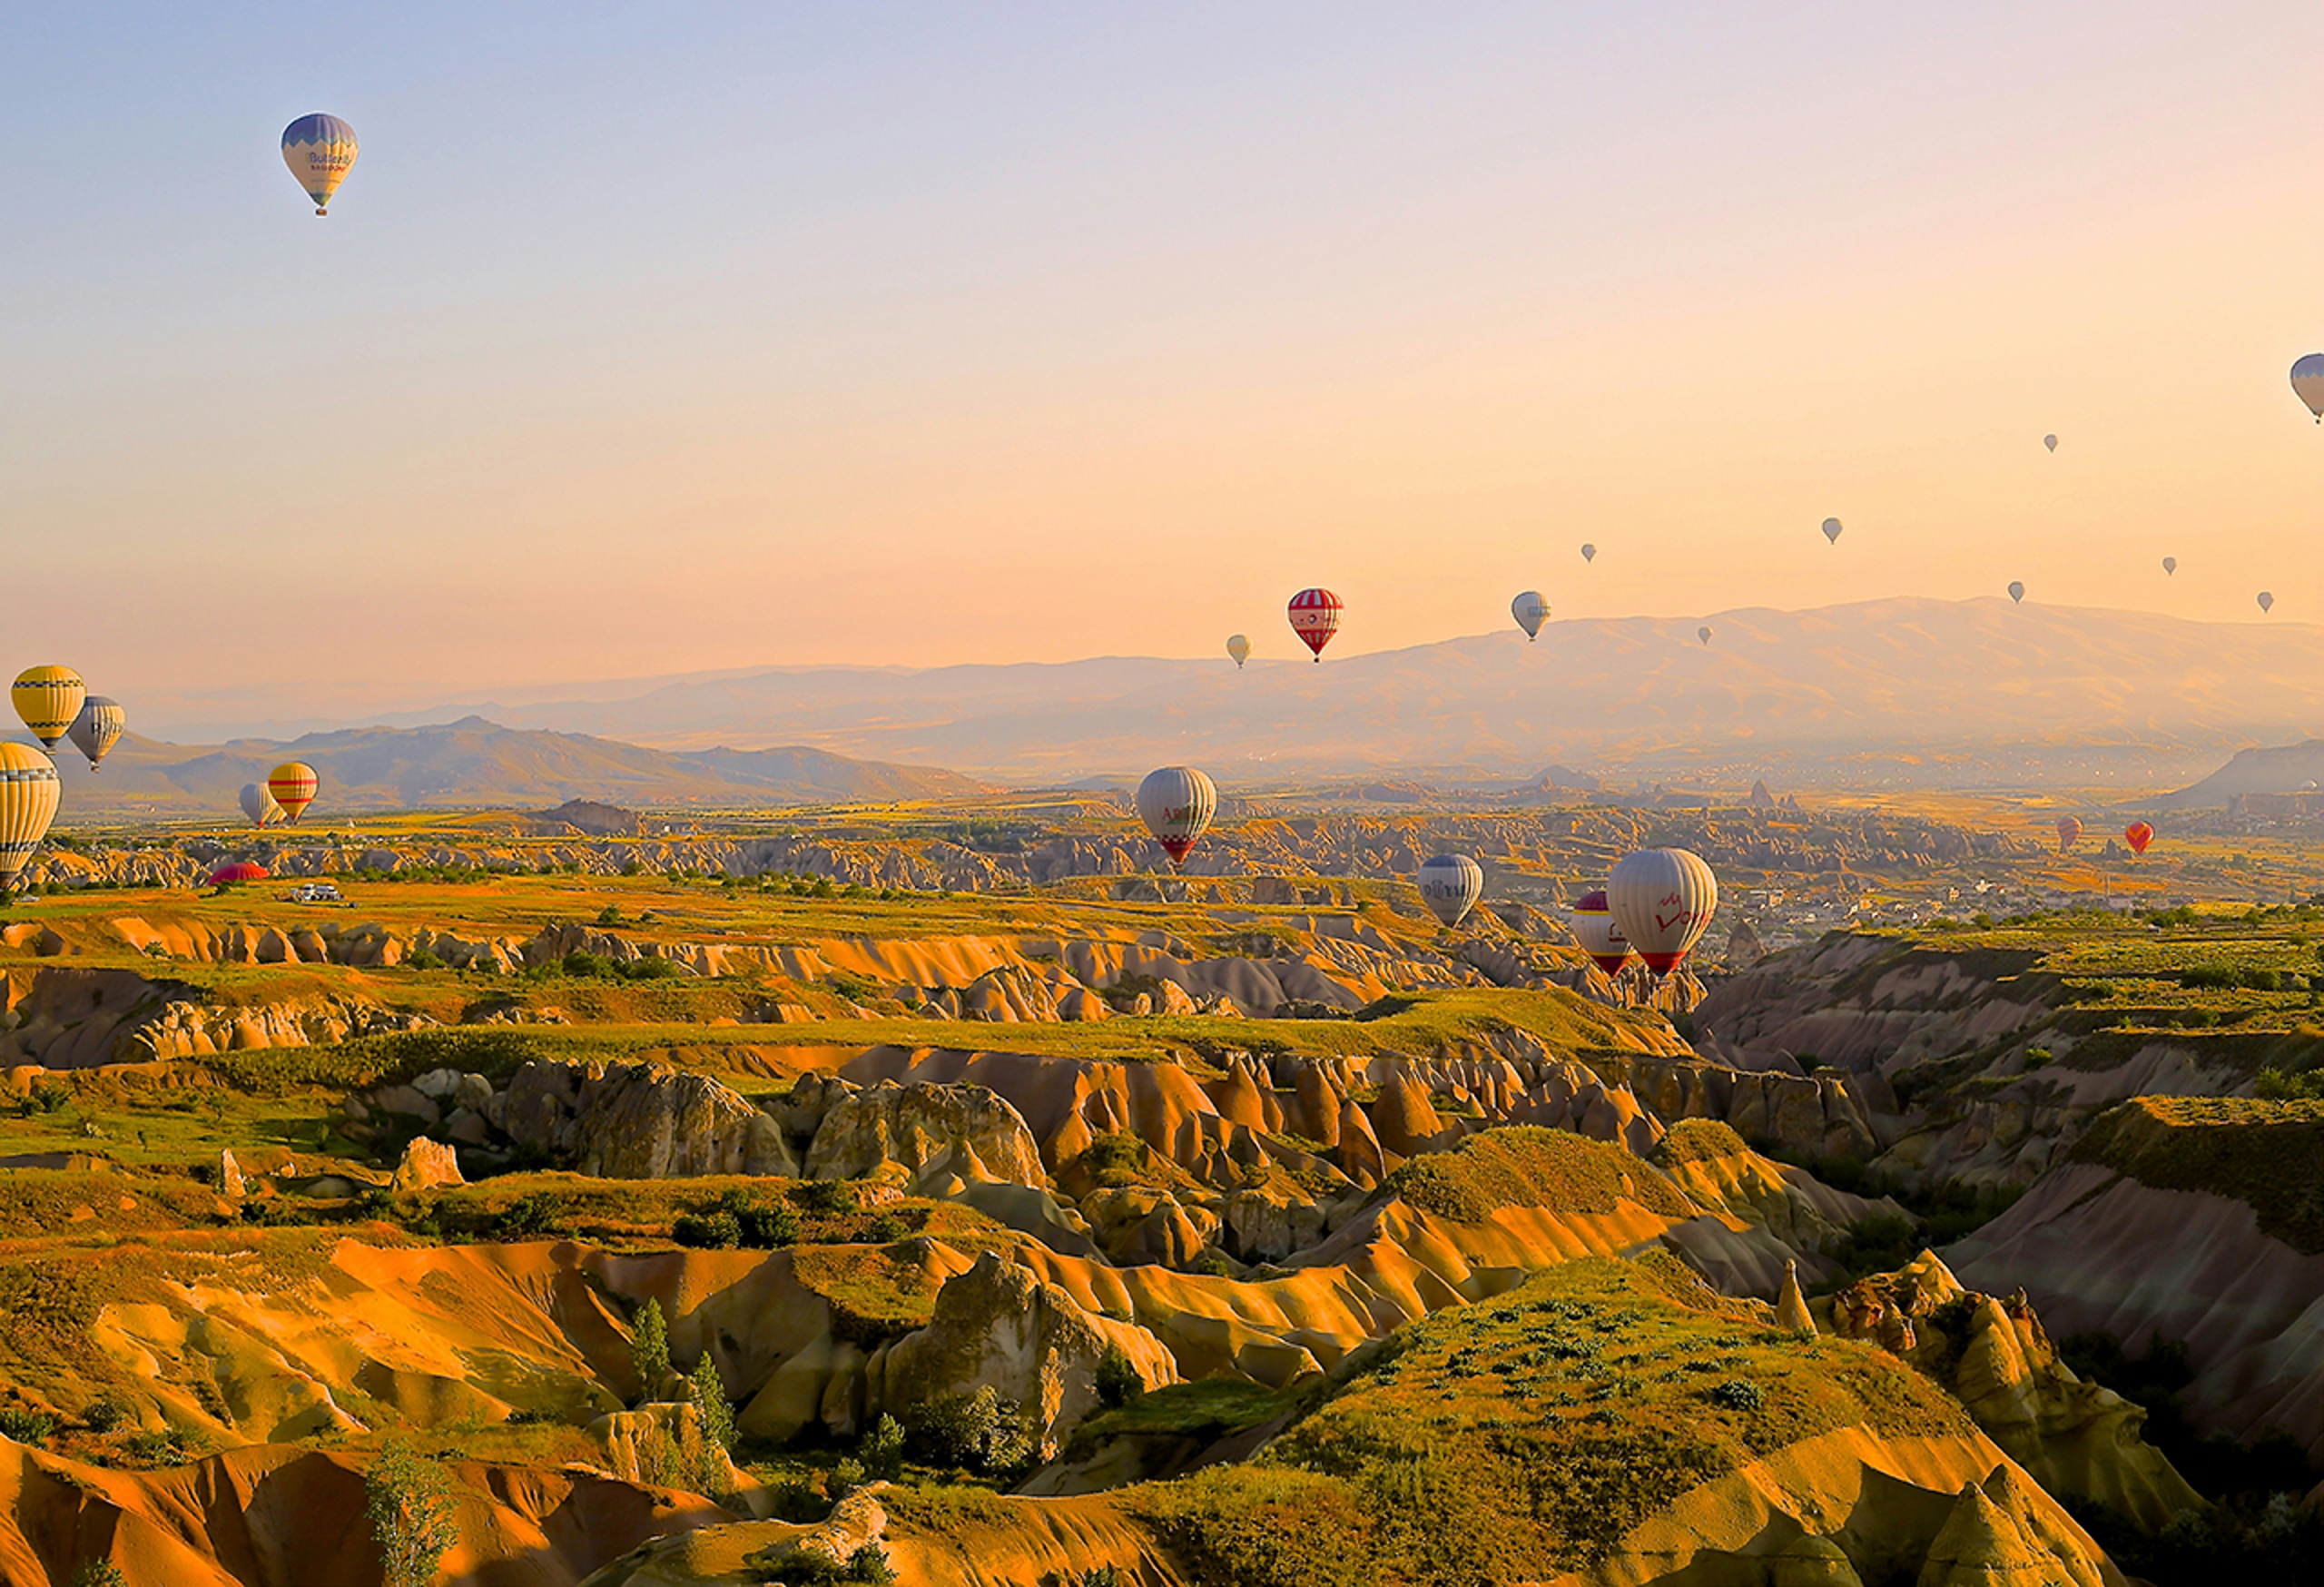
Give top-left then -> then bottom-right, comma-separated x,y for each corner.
0,0 -> 2324,715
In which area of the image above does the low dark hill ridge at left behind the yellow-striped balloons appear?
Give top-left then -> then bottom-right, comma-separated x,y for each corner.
55,715 -> 990,820
